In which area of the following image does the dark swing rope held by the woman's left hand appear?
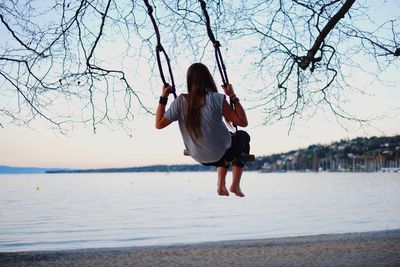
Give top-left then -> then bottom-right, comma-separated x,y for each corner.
143,0 -> 176,98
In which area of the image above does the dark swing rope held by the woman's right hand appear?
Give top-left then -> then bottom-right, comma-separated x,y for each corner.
199,0 -> 237,131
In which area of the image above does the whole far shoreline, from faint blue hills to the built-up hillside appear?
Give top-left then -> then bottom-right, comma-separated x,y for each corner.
0,135 -> 400,173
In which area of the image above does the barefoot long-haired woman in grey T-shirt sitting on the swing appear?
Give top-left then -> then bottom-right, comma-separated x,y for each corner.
156,63 -> 250,197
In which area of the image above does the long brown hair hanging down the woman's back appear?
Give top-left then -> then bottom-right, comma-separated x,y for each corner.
185,63 -> 218,139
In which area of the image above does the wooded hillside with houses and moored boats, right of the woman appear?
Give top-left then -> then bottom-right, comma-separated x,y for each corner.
248,135 -> 400,172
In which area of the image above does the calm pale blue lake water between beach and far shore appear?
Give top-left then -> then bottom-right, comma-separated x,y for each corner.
0,172 -> 400,252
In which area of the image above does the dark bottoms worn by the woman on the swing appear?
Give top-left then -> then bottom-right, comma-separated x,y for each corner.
202,130 -> 250,168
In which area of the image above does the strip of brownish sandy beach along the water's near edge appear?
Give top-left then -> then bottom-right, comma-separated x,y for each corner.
0,230 -> 400,267
